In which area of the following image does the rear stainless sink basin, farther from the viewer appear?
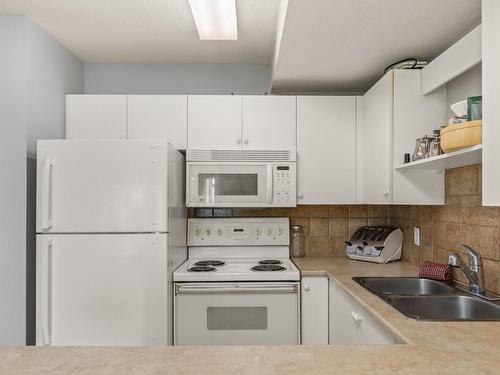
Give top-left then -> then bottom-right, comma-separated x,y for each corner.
352,277 -> 457,298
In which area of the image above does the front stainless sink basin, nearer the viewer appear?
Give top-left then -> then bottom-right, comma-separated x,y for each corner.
386,295 -> 500,321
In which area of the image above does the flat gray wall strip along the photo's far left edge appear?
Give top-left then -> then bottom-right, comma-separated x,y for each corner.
0,16 -> 27,345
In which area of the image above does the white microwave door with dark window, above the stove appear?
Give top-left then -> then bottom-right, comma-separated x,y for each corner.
186,162 -> 273,207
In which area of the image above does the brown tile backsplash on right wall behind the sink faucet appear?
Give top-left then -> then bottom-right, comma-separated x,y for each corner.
389,164 -> 500,293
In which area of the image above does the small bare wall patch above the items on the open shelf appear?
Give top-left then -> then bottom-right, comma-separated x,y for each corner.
446,64 -> 482,118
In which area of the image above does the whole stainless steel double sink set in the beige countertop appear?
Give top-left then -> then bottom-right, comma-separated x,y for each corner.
352,277 -> 500,321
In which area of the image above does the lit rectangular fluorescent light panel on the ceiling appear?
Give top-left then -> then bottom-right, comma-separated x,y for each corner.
189,0 -> 238,40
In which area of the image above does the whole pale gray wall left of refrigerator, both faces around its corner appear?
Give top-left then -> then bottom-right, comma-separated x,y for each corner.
0,16 -> 84,345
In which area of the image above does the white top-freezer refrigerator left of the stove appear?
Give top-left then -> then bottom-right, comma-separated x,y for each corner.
36,139 -> 187,346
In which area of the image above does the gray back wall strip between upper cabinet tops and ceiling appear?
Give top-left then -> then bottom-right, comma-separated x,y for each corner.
85,64 -> 271,94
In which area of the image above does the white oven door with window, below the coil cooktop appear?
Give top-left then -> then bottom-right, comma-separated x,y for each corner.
174,282 -> 300,345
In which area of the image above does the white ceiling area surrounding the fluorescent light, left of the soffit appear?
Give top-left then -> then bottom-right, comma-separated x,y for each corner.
0,0 -> 279,64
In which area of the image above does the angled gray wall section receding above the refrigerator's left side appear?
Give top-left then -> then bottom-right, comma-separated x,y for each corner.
27,21 -> 84,154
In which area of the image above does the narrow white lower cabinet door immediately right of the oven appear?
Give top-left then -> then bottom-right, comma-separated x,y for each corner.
301,277 -> 328,345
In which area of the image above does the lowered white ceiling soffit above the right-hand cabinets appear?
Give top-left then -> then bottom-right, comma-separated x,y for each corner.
272,0 -> 481,93
